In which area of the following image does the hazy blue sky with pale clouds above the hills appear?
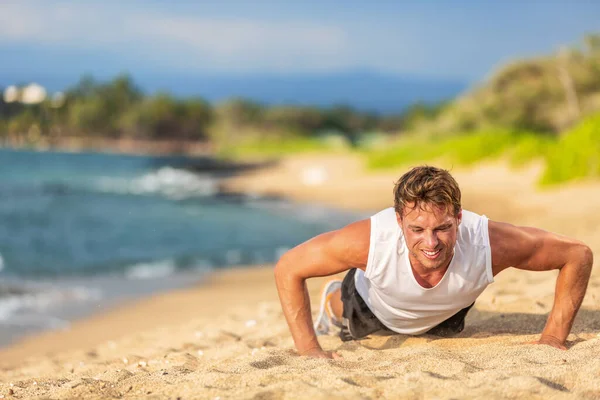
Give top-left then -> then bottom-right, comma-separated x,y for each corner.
0,0 -> 600,86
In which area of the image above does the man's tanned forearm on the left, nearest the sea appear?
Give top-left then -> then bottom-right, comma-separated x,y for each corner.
275,265 -> 321,354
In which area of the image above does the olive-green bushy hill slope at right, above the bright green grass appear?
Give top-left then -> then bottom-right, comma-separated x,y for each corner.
418,35 -> 600,134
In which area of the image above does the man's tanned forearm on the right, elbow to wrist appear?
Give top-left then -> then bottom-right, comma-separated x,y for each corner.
542,251 -> 592,343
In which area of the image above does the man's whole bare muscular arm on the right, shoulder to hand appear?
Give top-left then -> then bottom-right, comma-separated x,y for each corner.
489,221 -> 593,349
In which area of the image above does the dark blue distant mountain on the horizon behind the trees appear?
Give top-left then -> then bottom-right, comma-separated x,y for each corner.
0,71 -> 467,114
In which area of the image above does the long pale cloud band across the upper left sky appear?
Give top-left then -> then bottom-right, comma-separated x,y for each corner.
0,1 -> 351,71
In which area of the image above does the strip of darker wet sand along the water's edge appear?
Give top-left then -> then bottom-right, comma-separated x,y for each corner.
0,266 -> 278,368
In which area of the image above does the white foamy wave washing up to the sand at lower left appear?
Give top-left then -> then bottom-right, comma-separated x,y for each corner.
0,259 -> 213,332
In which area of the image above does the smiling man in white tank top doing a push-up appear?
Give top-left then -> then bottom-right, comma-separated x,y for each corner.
275,166 -> 593,358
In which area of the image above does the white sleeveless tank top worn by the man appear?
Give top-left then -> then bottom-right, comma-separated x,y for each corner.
354,208 -> 494,335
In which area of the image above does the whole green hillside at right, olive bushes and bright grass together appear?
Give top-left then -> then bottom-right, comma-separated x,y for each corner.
366,35 -> 600,185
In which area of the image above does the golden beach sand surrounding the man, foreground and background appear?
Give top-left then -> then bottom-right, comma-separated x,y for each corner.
0,156 -> 600,399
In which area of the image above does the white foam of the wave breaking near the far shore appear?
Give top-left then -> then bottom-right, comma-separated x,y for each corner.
97,167 -> 219,200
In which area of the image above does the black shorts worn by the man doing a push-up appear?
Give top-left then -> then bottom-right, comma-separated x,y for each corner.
340,268 -> 475,342
